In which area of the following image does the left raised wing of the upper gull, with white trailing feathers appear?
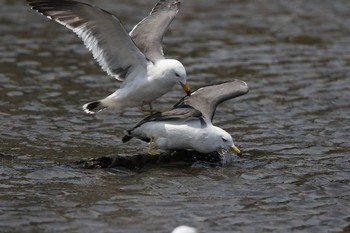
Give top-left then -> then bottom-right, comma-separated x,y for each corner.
27,0 -> 147,81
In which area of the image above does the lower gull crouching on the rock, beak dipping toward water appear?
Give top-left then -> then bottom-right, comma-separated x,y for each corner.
122,80 -> 249,156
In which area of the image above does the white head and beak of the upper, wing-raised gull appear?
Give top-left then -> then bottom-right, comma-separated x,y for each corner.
156,59 -> 191,96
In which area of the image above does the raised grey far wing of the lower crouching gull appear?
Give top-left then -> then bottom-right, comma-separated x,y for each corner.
173,80 -> 249,122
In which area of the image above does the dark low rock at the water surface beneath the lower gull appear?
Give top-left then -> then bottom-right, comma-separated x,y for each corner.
76,150 -> 222,170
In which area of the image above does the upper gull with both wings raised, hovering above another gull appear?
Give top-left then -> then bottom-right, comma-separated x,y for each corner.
27,0 -> 191,114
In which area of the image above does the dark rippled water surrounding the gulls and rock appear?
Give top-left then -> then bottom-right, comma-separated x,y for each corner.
0,0 -> 350,233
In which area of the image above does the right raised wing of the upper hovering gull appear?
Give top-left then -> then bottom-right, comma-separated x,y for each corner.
130,0 -> 181,62
